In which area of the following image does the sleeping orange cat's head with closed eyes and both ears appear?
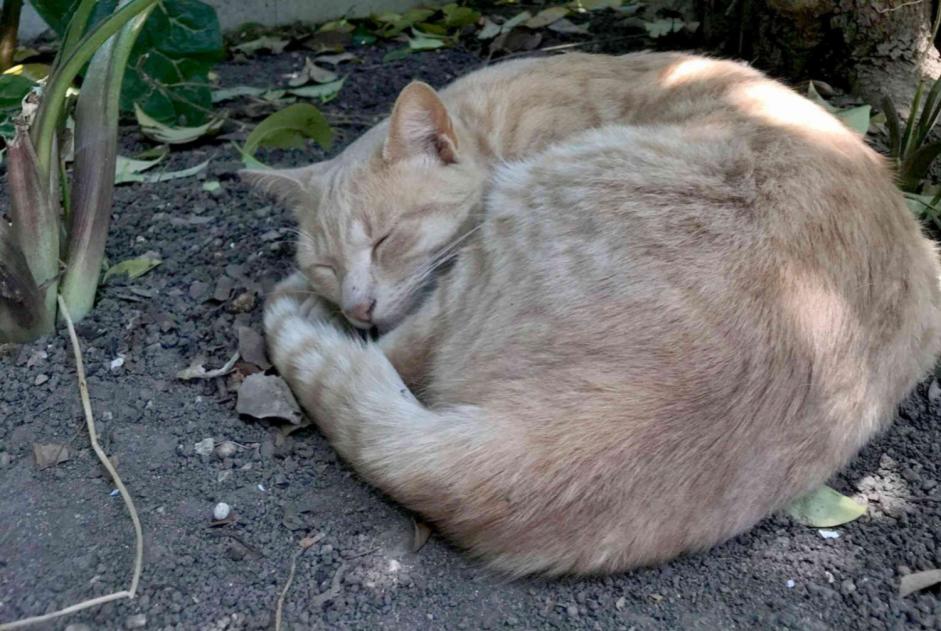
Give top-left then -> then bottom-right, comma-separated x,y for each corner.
242,82 -> 484,331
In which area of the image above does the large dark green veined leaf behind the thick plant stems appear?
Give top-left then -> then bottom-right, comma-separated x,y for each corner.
32,0 -> 223,126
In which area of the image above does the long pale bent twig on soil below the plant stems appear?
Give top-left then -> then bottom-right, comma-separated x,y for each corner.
0,296 -> 144,631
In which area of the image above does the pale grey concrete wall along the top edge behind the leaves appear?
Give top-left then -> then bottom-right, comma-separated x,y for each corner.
13,0 -> 442,40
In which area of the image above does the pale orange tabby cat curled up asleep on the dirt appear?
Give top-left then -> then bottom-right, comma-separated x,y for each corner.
246,53 -> 941,576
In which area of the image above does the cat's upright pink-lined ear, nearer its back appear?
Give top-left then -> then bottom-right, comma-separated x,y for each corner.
382,81 -> 457,164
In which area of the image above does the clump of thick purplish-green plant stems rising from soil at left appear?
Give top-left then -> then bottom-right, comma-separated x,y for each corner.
0,0 -> 158,341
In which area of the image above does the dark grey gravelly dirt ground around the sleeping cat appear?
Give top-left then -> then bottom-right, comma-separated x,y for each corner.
0,40 -> 941,631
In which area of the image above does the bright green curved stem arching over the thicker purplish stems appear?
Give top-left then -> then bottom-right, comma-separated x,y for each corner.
31,0 -> 158,177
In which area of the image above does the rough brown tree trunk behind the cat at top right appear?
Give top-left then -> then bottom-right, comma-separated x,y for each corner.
699,0 -> 941,109
